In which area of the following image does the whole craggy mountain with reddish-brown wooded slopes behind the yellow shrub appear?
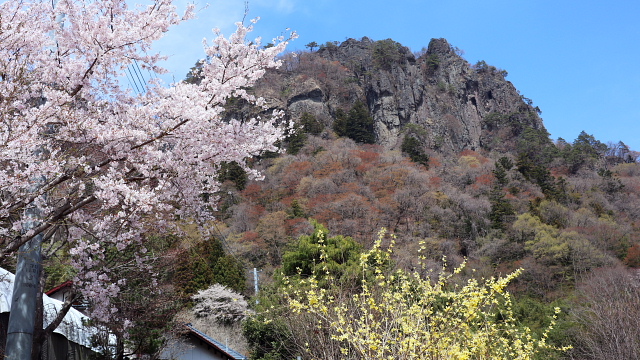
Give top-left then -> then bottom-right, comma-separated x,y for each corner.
208,38 -> 640,359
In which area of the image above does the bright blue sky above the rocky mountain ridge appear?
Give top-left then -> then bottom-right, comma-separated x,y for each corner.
156,0 -> 640,151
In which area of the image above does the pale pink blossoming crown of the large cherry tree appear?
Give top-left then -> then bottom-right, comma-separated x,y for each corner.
0,0 -> 295,330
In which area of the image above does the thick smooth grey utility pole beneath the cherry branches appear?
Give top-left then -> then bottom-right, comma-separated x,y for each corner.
5,205 -> 42,360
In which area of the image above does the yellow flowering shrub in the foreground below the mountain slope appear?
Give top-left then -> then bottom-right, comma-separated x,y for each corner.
286,230 -> 561,360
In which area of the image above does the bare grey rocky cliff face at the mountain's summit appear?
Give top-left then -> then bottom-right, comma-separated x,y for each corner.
250,38 -> 543,151
